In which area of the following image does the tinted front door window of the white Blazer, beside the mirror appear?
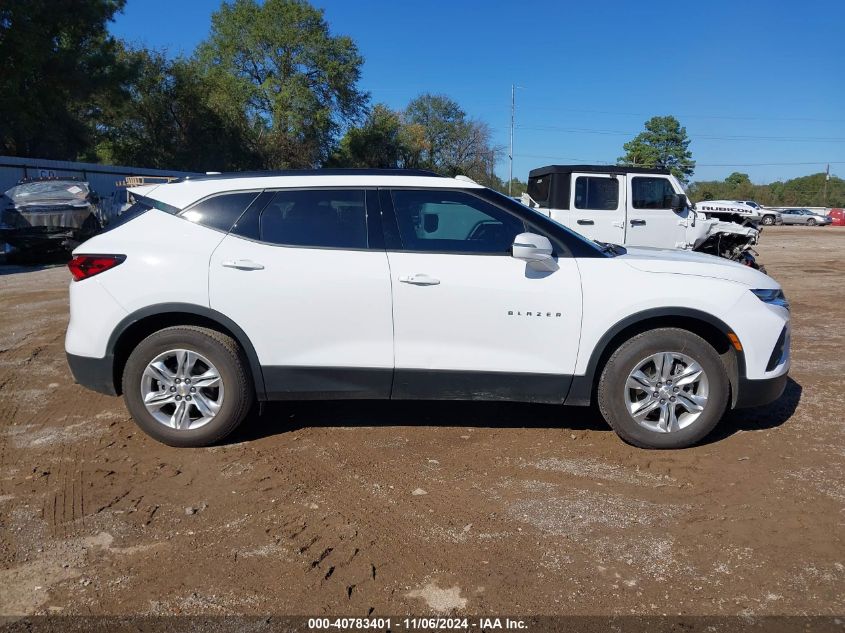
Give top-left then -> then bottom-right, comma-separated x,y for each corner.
393,190 -> 525,254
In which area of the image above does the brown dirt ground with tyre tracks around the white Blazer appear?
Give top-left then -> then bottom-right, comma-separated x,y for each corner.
0,227 -> 845,616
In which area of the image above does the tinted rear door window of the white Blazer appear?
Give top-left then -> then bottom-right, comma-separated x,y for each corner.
259,190 -> 367,248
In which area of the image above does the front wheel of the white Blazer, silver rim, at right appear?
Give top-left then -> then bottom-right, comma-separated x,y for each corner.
598,328 -> 730,448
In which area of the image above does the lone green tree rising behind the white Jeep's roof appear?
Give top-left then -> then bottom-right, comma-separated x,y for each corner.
618,116 -> 695,182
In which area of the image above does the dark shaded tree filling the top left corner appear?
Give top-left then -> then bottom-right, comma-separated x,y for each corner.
0,0 -> 128,159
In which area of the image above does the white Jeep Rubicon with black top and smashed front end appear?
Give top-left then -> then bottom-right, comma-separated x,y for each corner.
523,165 -> 762,269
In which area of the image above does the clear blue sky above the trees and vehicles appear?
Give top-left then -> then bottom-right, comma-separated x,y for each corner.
112,0 -> 845,182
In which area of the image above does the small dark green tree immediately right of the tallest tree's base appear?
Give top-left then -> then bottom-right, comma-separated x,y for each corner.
328,103 -> 404,168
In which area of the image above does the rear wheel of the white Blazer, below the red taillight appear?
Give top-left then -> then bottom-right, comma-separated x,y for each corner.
123,326 -> 255,447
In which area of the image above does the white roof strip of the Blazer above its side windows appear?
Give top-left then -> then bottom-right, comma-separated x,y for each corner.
138,169 -> 483,209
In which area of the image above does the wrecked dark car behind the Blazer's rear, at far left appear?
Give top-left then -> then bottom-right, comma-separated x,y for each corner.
0,178 -> 102,257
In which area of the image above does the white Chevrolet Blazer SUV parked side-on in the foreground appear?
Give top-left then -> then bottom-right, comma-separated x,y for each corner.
66,170 -> 789,448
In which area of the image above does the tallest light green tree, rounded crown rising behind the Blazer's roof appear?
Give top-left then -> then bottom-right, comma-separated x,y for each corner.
197,0 -> 369,168
